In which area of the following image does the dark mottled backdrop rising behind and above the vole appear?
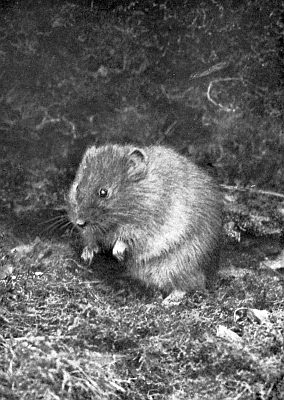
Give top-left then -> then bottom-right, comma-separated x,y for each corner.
0,0 -> 284,212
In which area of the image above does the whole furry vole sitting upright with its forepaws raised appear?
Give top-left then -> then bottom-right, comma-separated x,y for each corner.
68,144 -> 223,294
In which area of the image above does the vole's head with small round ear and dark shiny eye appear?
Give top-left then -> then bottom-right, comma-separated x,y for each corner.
68,145 -> 148,234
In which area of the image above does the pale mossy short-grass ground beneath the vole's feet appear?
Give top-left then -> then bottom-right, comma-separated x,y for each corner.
0,212 -> 284,400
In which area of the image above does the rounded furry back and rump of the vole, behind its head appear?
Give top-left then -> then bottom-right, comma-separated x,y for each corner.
125,146 -> 222,291
